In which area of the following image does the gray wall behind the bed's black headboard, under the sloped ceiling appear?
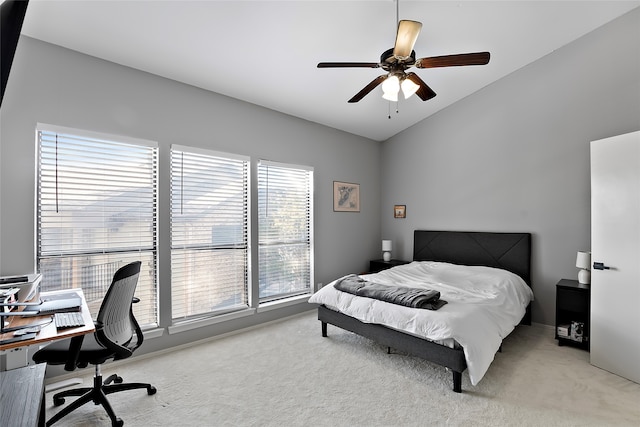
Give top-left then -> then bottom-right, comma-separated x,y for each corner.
381,9 -> 640,324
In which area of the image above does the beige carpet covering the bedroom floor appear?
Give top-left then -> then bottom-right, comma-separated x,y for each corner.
46,312 -> 640,427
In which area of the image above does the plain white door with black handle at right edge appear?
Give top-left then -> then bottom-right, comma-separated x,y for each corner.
590,132 -> 640,383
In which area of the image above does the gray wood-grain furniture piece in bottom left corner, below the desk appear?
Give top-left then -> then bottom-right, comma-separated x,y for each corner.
0,363 -> 47,427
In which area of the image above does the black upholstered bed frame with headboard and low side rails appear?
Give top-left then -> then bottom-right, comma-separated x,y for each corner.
318,230 -> 531,393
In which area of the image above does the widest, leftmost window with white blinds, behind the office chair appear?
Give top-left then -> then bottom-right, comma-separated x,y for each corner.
36,124 -> 157,325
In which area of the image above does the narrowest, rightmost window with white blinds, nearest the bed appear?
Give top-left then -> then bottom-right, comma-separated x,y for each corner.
258,161 -> 313,302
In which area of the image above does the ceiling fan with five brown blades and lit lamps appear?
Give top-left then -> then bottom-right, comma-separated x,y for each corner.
318,20 -> 490,102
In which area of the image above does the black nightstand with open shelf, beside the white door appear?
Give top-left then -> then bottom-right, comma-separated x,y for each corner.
556,279 -> 591,351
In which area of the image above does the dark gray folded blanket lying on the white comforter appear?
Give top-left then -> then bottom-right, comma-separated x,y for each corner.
333,274 -> 447,310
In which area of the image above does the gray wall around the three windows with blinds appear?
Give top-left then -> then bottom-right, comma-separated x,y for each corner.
0,37 -> 380,350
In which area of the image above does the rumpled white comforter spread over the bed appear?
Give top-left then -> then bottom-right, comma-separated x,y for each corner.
309,261 -> 533,385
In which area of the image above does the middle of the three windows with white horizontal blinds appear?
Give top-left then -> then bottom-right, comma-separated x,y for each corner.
171,146 -> 249,320
